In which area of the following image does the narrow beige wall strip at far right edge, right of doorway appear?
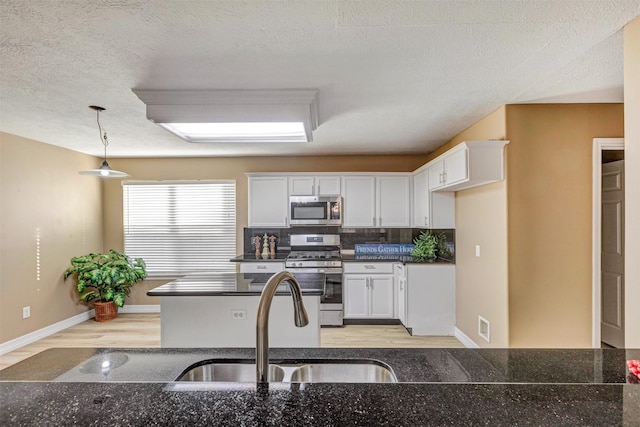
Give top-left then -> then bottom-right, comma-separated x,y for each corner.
624,18 -> 640,348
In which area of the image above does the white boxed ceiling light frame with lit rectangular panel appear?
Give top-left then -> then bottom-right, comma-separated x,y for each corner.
133,89 -> 318,143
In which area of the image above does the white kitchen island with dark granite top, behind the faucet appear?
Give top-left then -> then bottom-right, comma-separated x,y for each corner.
147,273 -> 324,348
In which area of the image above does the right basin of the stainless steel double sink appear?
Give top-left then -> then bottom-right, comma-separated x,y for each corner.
290,363 -> 398,383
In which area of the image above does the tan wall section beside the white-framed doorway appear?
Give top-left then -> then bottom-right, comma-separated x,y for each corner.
506,104 -> 623,348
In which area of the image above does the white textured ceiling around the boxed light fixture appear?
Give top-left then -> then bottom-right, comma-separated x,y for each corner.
0,0 -> 640,157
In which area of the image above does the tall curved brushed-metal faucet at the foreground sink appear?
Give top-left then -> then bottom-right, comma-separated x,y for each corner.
256,271 -> 309,383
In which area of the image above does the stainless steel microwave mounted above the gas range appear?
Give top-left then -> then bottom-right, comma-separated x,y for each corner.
289,196 -> 342,225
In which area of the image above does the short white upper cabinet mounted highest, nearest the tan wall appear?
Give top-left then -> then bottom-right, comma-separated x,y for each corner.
428,141 -> 509,191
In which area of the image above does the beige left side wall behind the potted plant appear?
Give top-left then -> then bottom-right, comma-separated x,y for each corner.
0,132 -> 103,343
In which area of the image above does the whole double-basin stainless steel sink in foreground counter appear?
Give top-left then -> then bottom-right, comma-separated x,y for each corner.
176,359 -> 398,383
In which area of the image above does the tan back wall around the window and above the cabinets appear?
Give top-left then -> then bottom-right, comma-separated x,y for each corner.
104,155 -> 426,304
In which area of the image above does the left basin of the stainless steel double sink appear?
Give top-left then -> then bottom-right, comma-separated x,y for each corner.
176,363 -> 285,382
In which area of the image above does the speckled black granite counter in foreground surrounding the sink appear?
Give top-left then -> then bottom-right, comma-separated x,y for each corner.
0,348 -> 640,426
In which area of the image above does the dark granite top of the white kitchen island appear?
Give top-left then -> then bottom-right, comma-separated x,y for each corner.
147,273 -> 324,297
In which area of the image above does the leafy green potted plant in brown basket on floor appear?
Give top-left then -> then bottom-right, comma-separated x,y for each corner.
64,249 -> 147,322
